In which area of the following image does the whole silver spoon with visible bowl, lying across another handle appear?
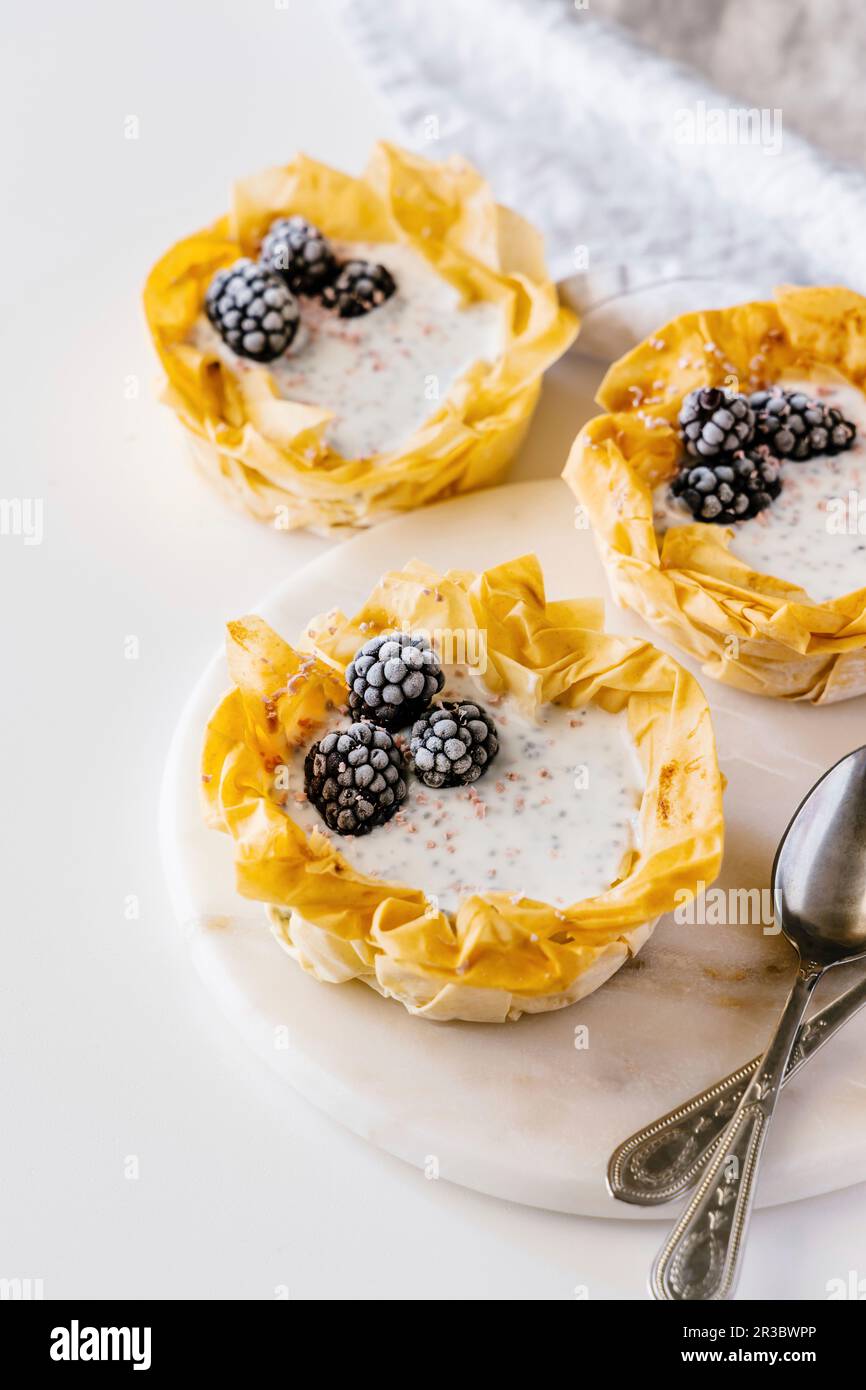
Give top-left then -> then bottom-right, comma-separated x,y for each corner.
651,748 -> 866,1301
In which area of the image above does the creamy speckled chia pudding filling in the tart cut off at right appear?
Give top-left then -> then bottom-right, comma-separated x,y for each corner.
653,381 -> 866,603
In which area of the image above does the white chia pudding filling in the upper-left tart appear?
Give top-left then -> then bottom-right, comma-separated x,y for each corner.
189,242 -> 505,459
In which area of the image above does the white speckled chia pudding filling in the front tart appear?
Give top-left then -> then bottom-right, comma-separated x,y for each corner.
275,667 -> 644,912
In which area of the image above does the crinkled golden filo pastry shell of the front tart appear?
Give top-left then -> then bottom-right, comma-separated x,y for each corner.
202,556 -> 723,1022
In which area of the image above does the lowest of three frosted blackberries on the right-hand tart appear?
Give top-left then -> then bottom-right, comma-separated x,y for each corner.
671,445 -> 781,525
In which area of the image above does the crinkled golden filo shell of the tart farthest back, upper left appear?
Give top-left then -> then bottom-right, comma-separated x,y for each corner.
145,143 -> 577,532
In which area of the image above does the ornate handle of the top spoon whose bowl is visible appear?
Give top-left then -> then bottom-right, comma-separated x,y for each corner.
651,962 -> 822,1302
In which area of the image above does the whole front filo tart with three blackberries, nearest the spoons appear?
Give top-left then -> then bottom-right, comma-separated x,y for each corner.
202,556 -> 723,1022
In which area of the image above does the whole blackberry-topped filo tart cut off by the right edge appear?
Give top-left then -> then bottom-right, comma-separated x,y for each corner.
564,286 -> 866,703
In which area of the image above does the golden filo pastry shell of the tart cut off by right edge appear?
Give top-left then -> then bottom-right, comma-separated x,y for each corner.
563,286 -> 866,705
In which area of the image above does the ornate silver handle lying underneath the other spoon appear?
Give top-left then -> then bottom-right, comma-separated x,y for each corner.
607,976 -> 866,1207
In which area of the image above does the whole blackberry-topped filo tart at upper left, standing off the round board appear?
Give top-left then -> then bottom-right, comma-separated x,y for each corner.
145,143 -> 577,532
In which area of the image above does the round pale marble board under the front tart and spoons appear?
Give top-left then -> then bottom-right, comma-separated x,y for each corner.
161,481 -> 866,1218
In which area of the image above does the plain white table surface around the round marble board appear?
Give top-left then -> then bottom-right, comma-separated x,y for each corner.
0,0 -> 866,1300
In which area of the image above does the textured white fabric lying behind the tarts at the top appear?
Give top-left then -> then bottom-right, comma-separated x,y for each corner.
342,0 -> 866,307
